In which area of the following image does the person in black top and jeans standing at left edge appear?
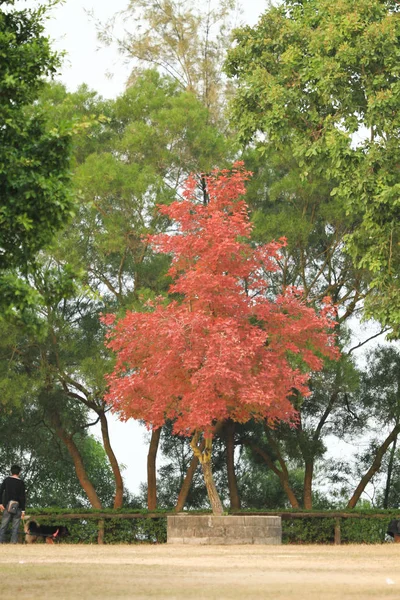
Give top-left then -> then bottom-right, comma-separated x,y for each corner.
0,465 -> 25,544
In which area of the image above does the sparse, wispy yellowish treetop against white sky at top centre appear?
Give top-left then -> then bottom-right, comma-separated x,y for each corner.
99,0 -> 238,121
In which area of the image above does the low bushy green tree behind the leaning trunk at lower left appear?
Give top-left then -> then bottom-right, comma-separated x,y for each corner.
0,398 -> 114,508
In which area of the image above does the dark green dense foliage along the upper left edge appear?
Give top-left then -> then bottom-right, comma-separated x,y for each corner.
0,0 -> 72,314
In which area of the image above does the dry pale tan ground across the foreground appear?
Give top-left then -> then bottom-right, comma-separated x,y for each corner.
0,544 -> 400,600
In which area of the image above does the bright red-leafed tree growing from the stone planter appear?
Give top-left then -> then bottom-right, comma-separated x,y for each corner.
104,163 -> 336,514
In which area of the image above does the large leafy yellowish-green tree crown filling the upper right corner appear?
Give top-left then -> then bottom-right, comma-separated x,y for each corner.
226,0 -> 400,335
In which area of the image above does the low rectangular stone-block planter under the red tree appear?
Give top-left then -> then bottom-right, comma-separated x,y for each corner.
167,515 -> 282,545
